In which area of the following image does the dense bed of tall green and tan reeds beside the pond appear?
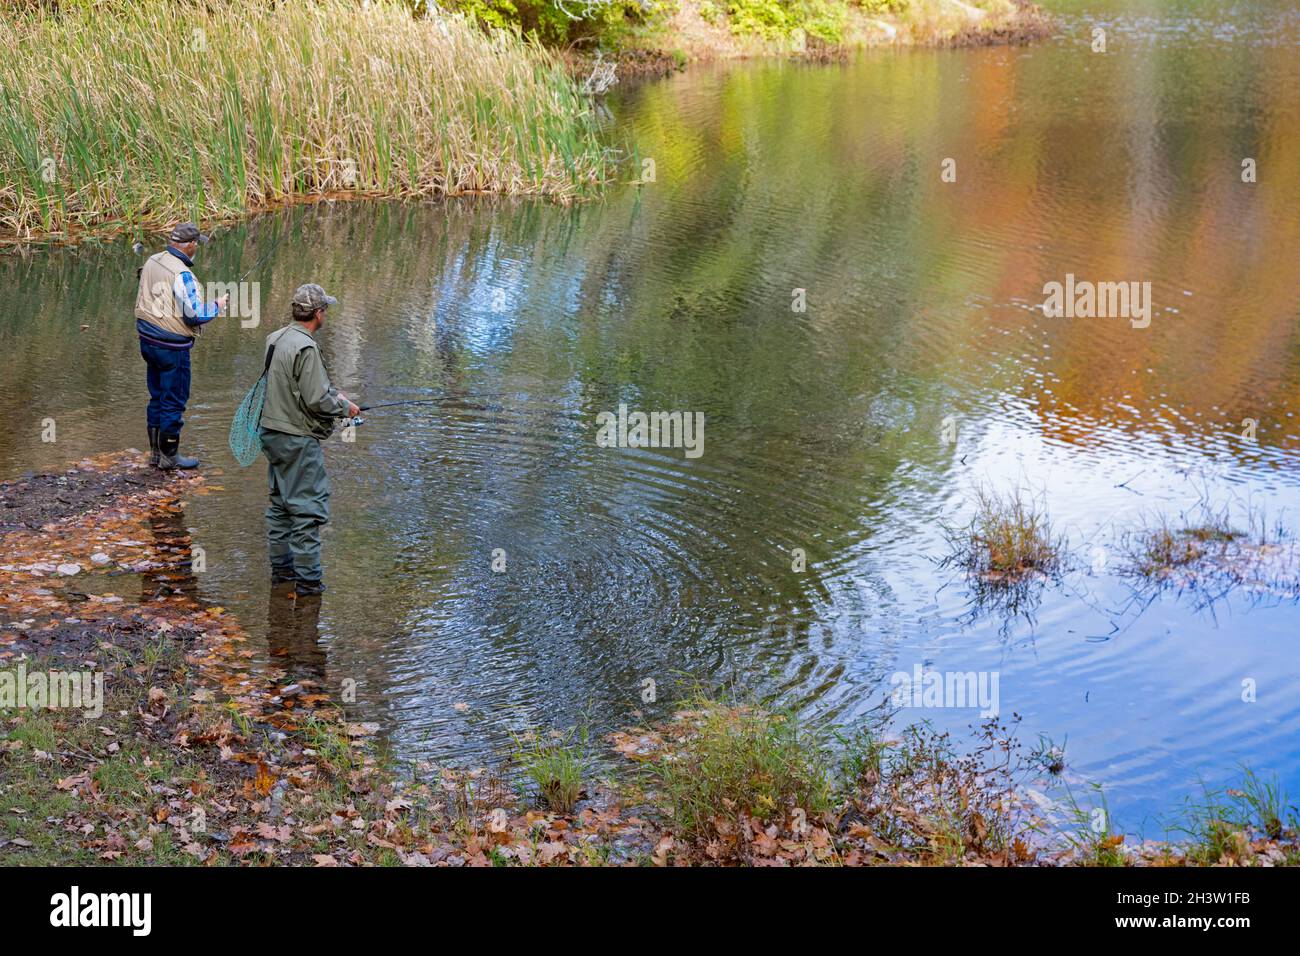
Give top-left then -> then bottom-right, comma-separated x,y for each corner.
0,0 -> 608,239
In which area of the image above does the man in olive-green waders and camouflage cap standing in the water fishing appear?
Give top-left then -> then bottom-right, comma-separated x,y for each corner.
261,284 -> 361,594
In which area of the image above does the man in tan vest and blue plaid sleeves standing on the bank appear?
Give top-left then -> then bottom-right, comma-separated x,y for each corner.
135,222 -> 226,470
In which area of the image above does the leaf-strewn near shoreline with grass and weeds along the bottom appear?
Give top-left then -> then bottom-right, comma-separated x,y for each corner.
0,449 -> 1300,866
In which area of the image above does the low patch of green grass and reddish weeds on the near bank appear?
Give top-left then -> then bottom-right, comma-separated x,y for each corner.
649,698 -> 1034,865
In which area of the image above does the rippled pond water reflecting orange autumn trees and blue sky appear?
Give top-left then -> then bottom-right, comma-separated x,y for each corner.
0,3 -> 1300,826
